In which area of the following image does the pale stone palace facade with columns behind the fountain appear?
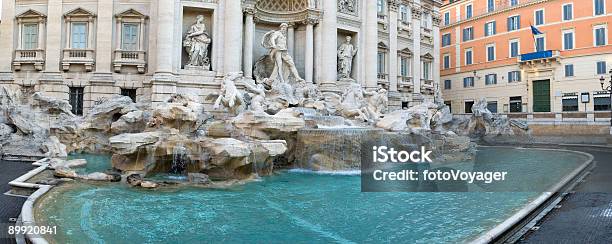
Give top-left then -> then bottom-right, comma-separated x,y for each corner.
0,0 -> 441,114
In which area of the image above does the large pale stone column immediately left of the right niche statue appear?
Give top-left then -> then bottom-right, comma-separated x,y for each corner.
319,1 -> 340,93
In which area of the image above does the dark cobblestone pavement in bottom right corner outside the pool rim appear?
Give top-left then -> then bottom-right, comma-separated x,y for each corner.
520,147 -> 612,243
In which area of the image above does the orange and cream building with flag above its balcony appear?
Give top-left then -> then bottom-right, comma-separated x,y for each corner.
440,0 -> 612,115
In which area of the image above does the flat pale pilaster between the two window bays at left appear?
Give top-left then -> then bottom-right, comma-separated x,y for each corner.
96,0 -> 113,74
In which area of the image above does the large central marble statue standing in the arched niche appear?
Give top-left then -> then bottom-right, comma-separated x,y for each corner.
261,23 -> 303,83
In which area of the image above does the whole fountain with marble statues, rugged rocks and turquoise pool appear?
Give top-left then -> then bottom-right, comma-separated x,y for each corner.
0,22 -> 582,243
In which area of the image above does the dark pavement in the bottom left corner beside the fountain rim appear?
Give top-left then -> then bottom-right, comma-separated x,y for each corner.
0,161 -> 34,244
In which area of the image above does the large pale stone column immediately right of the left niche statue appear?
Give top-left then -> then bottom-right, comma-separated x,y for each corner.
223,0 -> 242,73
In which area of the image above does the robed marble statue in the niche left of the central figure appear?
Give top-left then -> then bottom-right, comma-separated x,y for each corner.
183,15 -> 211,70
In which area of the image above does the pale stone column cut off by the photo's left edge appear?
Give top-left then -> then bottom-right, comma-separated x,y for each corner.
0,1 -> 15,78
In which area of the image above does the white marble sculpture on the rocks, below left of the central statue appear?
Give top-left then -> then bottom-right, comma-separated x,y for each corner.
213,72 -> 246,114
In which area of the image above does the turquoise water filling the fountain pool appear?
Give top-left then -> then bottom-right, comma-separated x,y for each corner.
36,149 -> 585,243
